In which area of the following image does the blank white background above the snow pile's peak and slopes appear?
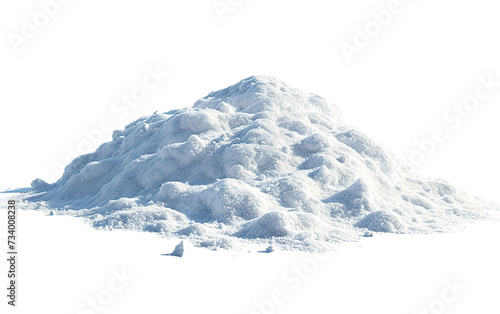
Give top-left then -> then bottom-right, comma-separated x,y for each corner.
0,0 -> 500,200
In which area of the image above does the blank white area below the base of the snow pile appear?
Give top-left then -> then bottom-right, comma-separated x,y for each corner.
0,206 -> 500,314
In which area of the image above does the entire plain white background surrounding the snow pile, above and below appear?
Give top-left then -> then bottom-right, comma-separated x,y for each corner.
0,0 -> 500,314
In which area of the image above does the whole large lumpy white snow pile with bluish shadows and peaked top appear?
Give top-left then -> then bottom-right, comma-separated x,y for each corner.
28,76 -> 492,250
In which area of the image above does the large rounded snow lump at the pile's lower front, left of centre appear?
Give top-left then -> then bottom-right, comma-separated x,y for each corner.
203,179 -> 270,222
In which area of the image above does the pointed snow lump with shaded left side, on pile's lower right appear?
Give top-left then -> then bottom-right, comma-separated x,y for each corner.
325,178 -> 374,217
